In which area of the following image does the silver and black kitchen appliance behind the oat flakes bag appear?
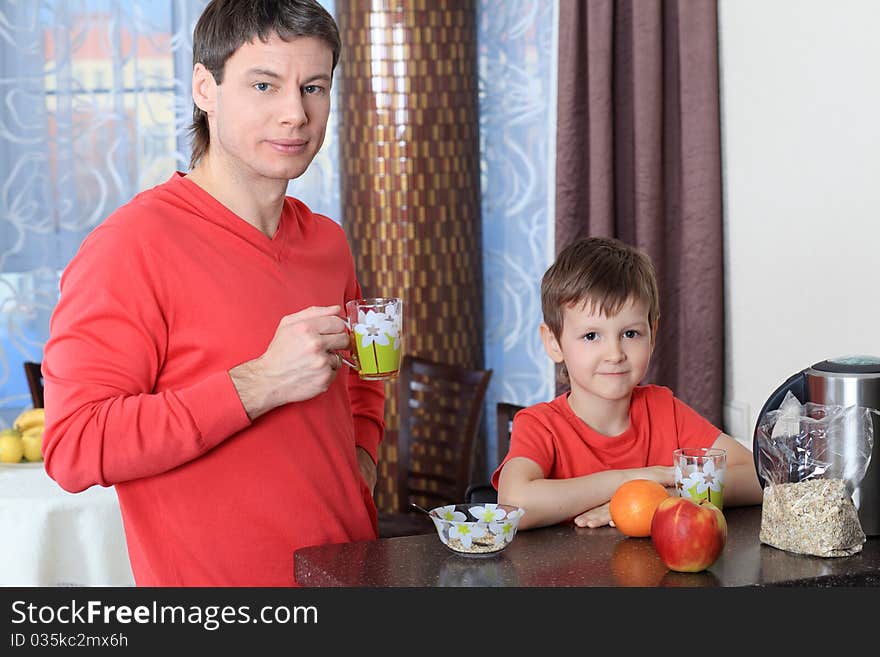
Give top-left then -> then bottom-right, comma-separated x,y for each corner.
752,356 -> 880,536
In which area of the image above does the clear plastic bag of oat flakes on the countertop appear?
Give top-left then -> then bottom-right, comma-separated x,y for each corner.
755,392 -> 877,557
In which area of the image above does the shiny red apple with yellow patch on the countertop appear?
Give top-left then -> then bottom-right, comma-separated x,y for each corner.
651,497 -> 727,573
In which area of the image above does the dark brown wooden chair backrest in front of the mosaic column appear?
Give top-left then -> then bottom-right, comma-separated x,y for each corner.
397,355 -> 492,512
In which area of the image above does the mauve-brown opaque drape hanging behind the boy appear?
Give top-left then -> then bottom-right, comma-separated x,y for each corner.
556,0 -> 724,426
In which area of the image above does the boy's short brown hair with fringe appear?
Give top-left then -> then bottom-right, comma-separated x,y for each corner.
541,237 -> 660,340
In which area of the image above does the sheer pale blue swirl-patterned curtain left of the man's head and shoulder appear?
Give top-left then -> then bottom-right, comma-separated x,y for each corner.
0,0 -> 206,418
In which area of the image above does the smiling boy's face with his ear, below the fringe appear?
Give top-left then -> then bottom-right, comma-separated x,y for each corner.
541,300 -> 656,401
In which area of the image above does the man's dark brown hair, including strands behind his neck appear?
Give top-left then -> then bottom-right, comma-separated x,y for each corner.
189,0 -> 342,169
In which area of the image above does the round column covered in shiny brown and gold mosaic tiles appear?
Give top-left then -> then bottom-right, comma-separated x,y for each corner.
336,0 -> 484,512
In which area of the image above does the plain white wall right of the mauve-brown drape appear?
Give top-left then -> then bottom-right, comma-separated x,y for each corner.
719,0 -> 880,445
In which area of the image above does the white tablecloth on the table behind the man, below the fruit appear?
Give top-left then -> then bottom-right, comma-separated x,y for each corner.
0,463 -> 134,586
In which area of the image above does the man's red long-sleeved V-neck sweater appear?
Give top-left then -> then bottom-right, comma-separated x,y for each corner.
43,173 -> 384,586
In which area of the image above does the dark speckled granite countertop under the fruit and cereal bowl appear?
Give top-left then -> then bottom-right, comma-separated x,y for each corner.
294,506 -> 880,587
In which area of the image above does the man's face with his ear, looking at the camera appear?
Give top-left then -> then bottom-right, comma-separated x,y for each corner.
193,35 -> 333,181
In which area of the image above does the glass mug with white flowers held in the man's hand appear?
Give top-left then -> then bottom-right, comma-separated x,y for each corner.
337,297 -> 403,381
